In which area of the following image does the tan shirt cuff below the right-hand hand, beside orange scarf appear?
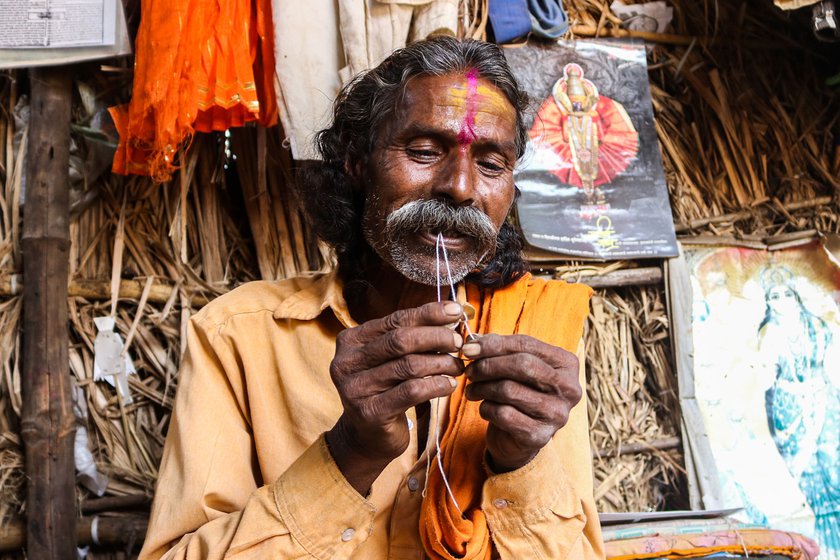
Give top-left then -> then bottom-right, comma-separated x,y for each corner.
481,443 -> 585,531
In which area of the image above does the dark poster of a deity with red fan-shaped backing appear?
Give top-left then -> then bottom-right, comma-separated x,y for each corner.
505,40 -> 677,259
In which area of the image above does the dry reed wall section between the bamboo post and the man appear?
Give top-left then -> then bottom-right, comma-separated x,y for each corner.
60,128 -> 327,495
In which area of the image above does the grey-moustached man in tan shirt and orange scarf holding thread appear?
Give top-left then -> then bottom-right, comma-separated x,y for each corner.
141,38 -> 603,560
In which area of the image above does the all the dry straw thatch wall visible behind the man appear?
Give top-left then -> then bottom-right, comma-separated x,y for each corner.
0,0 -> 840,540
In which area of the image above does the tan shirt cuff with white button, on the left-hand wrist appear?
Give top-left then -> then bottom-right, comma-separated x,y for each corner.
273,434 -> 376,559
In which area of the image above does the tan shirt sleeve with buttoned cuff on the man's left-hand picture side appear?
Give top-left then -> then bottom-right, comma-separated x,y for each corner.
140,320 -> 374,559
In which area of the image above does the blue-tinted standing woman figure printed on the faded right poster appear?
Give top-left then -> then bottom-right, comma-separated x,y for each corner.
758,266 -> 840,559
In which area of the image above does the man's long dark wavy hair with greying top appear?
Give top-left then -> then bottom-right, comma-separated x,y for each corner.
298,37 -> 528,297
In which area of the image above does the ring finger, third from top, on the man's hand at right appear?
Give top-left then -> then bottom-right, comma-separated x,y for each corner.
466,379 -> 577,424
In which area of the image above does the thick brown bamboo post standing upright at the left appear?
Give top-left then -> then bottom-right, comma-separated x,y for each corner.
21,67 -> 76,559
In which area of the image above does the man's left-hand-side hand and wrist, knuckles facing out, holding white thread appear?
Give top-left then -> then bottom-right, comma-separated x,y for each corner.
326,302 -> 464,496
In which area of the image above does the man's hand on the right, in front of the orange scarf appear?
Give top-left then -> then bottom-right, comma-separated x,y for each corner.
462,334 -> 582,473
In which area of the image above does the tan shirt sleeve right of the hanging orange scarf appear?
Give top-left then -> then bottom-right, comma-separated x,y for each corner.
482,341 -> 605,560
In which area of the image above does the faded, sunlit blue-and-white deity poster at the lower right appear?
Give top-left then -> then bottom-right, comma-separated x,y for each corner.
680,243 -> 840,560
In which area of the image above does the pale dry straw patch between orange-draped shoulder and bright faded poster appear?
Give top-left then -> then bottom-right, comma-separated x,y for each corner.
586,286 -> 684,511
